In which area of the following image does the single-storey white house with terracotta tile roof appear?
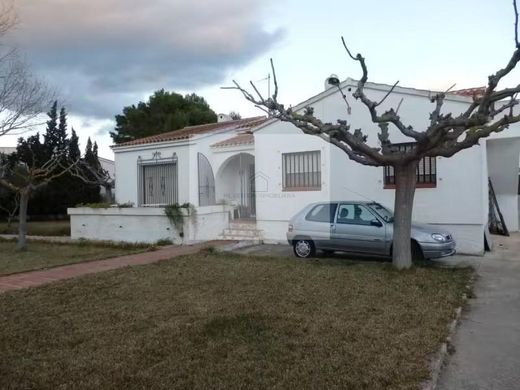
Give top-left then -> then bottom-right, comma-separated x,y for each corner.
71,79 -> 520,253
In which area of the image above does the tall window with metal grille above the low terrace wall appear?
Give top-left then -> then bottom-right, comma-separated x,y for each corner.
137,153 -> 178,206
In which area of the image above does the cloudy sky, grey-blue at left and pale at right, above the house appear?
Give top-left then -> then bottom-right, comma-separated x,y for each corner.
0,0 -> 520,158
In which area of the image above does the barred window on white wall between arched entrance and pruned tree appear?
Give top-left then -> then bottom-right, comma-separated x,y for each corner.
282,150 -> 321,191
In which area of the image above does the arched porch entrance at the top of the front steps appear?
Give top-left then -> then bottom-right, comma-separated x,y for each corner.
216,153 -> 256,218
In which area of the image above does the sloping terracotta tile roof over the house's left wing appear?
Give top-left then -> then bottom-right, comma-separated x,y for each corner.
113,116 -> 267,148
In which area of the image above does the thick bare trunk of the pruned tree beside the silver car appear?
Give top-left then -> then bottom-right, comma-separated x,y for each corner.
392,161 -> 417,269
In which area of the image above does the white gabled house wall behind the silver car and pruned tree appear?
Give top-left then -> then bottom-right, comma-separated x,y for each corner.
255,82 -> 512,253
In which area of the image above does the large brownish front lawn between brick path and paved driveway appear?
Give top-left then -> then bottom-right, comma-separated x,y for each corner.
0,252 -> 471,390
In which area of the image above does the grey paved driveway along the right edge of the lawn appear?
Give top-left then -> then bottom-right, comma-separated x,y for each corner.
437,233 -> 520,390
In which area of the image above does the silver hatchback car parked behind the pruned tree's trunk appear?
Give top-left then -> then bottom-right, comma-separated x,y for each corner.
287,201 -> 455,260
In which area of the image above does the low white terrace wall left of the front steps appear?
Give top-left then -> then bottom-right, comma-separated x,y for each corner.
67,206 -> 230,244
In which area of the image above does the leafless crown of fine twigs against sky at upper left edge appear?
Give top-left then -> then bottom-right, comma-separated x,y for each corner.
0,0 -> 53,136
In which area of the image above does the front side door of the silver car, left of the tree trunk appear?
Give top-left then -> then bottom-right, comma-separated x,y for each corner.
331,203 -> 386,255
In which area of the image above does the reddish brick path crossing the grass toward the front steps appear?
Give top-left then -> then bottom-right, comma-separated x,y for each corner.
0,241 -> 229,293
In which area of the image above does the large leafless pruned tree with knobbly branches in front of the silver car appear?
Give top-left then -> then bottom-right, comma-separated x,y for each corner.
231,0 -> 520,269
